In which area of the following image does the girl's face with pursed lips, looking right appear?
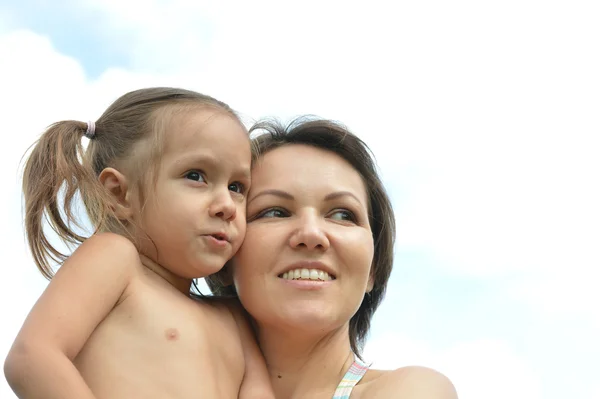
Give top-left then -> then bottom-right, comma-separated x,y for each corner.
139,108 -> 251,279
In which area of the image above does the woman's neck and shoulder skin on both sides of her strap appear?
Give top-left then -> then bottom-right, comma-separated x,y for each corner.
259,328 -> 458,399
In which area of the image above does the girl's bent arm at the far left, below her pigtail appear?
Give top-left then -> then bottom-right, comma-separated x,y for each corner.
4,233 -> 139,399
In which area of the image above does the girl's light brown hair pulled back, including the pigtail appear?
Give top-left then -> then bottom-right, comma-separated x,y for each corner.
23,87 -> 241,279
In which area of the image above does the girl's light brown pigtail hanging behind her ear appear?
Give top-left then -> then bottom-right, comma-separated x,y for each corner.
23,121 -> 101,279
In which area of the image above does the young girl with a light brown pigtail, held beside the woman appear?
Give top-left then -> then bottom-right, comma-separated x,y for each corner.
4,88 -> 273,399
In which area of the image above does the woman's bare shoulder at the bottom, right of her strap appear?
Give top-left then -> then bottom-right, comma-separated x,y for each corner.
353,366 -> 458,399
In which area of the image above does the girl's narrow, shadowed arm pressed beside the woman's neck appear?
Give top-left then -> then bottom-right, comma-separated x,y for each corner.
228,299 -> 275,399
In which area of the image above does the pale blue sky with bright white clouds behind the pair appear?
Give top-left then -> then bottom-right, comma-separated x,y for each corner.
0,0 -> 600,399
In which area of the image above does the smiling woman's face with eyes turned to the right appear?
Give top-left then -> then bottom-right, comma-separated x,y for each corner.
233,144 -> 373,331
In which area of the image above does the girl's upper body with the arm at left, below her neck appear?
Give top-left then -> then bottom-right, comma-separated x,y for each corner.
2,235 -> 244,399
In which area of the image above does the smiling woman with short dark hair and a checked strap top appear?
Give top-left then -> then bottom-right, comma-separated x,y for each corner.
209,120 -> 457,399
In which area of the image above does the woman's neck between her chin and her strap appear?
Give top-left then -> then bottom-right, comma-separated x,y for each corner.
258,325 -> 354,399
